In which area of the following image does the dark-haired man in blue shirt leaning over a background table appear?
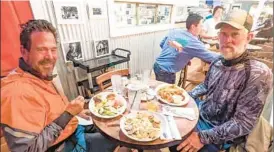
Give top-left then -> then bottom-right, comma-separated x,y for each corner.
153,14 -> 219,84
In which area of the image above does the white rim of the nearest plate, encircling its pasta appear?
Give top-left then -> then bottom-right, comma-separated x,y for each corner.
120,110 -> 163,142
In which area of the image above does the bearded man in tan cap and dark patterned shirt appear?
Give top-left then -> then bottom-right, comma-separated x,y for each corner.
170,10 -> 273,152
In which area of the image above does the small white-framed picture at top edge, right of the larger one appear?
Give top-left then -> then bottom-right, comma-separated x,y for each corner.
88,0 -> 107,19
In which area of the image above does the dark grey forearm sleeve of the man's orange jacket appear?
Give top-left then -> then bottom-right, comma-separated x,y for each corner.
1,111 -> 73,152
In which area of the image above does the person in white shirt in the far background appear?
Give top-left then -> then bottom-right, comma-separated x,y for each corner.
200,6 -> 224,40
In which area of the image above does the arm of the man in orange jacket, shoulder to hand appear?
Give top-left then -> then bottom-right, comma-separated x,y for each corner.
1,83 -> 84,152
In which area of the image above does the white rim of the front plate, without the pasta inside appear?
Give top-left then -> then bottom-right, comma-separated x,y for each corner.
120,111 -> 163,142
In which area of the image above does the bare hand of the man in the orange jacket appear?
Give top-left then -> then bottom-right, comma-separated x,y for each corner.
66,96 -> 85,116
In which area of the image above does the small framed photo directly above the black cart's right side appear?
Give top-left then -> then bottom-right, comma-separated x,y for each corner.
94,39 -> 110,58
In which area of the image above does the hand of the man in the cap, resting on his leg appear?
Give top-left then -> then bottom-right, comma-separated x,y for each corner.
177,132 -> 204,152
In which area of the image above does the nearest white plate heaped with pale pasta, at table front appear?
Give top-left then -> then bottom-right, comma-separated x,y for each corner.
120,111 -> 163,142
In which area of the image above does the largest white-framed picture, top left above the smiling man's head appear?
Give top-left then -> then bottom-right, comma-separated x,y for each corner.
53,0 -> 85,24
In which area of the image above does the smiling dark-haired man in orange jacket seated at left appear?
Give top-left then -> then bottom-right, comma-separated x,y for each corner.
1,20 -> 116,152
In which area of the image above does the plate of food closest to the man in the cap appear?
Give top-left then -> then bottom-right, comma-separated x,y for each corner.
155,84 -> 189,106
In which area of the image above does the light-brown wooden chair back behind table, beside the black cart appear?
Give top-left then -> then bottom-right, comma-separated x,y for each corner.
96,69 -> 129,91
